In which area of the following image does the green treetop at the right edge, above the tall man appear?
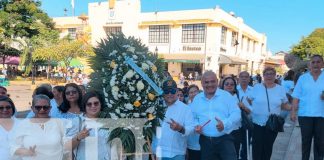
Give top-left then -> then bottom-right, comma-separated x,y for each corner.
290,28 -> 324,59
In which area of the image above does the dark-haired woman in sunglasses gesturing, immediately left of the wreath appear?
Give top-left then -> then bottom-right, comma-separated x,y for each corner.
67,91 -> 110,160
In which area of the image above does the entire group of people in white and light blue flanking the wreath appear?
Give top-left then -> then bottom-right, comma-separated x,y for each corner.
0,55 -> 324,160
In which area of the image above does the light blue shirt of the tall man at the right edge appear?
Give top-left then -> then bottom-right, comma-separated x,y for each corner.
291,71 -> 324,117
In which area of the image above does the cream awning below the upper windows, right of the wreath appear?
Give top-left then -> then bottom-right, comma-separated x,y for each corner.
159,54 -> 205,64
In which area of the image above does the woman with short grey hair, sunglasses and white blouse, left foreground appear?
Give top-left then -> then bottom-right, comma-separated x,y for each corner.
10,94 -> 64,160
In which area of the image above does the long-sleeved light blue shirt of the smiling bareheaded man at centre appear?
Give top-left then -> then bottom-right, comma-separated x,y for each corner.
191,88 -> 241,137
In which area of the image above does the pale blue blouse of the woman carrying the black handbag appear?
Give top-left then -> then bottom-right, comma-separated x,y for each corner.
248,83 -> 288,126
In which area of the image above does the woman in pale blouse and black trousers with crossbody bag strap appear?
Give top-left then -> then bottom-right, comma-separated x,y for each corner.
248,67 -> 291,160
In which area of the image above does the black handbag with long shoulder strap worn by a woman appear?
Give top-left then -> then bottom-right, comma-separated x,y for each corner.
264,85 -> 285,132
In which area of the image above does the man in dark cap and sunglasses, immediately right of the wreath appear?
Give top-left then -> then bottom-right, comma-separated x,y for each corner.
153,80 -> 195,160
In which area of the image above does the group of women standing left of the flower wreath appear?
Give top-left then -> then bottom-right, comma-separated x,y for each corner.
0,83 -> 111,160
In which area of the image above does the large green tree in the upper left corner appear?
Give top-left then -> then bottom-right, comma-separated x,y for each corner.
0,0 -> 58,73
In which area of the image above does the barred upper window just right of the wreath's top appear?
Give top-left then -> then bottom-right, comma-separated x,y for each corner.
149,25 -> 170,43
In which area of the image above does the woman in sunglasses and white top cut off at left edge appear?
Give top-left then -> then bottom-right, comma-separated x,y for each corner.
0,96 -> 18,160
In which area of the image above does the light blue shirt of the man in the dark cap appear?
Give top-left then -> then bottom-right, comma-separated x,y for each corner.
152,100 -> 195,158
